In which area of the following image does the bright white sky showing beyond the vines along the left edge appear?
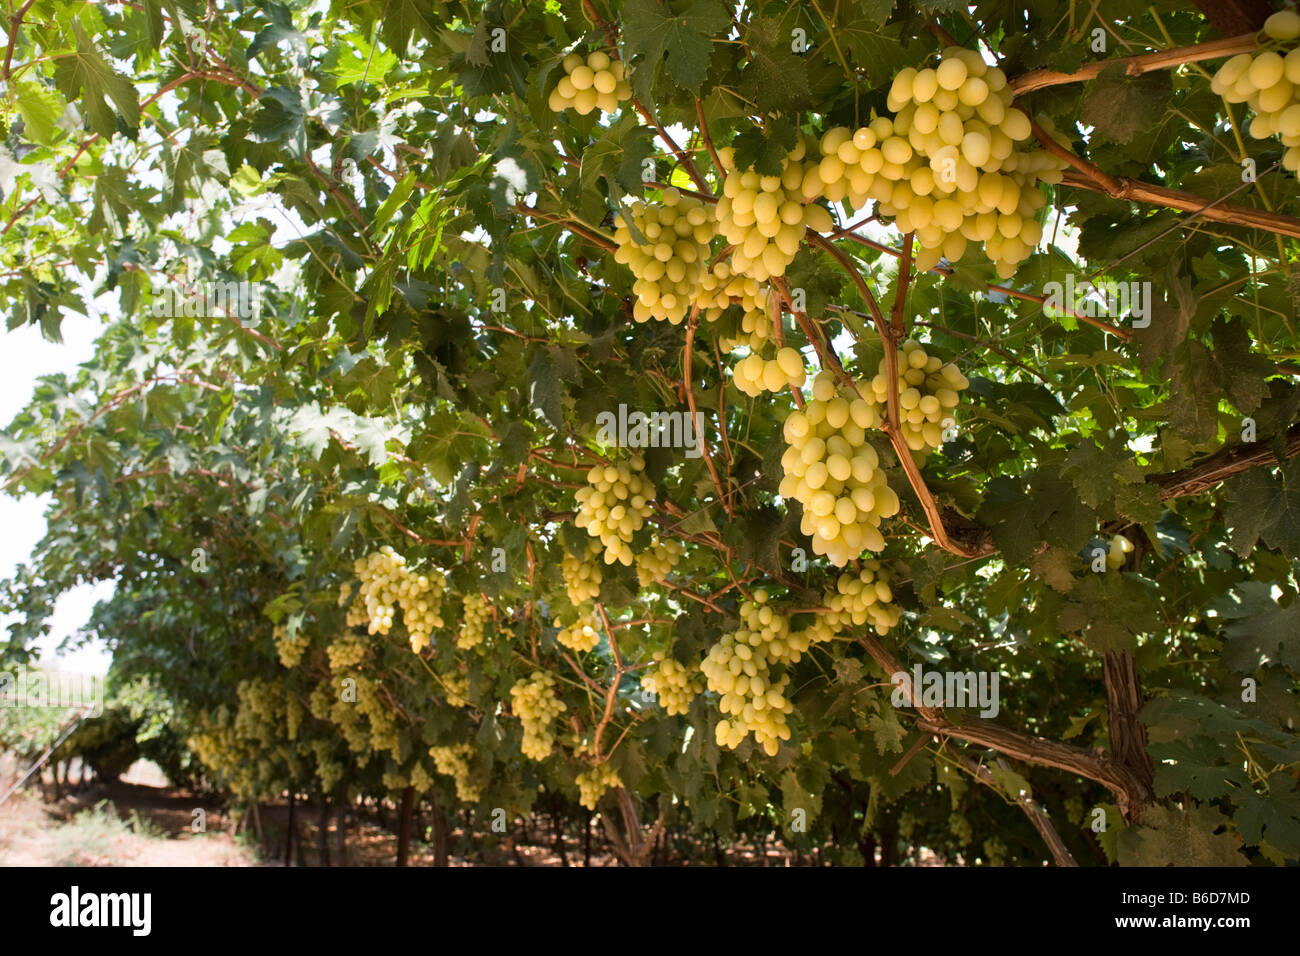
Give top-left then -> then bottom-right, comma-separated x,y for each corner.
0,313 -> 113,674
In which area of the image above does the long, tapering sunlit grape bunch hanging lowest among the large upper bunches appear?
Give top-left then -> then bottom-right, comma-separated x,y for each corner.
780,372 -> 900,567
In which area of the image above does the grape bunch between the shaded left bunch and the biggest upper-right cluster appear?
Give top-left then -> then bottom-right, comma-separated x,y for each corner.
715,143 -> 835,282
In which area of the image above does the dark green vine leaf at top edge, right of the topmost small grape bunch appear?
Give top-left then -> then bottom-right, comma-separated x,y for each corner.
623,0 -> 731,103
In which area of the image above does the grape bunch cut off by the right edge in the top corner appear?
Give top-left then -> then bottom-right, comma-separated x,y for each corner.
1210,10 -> 1300,173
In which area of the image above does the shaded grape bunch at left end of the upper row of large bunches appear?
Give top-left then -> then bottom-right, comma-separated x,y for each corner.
614,187 -> 715,325
